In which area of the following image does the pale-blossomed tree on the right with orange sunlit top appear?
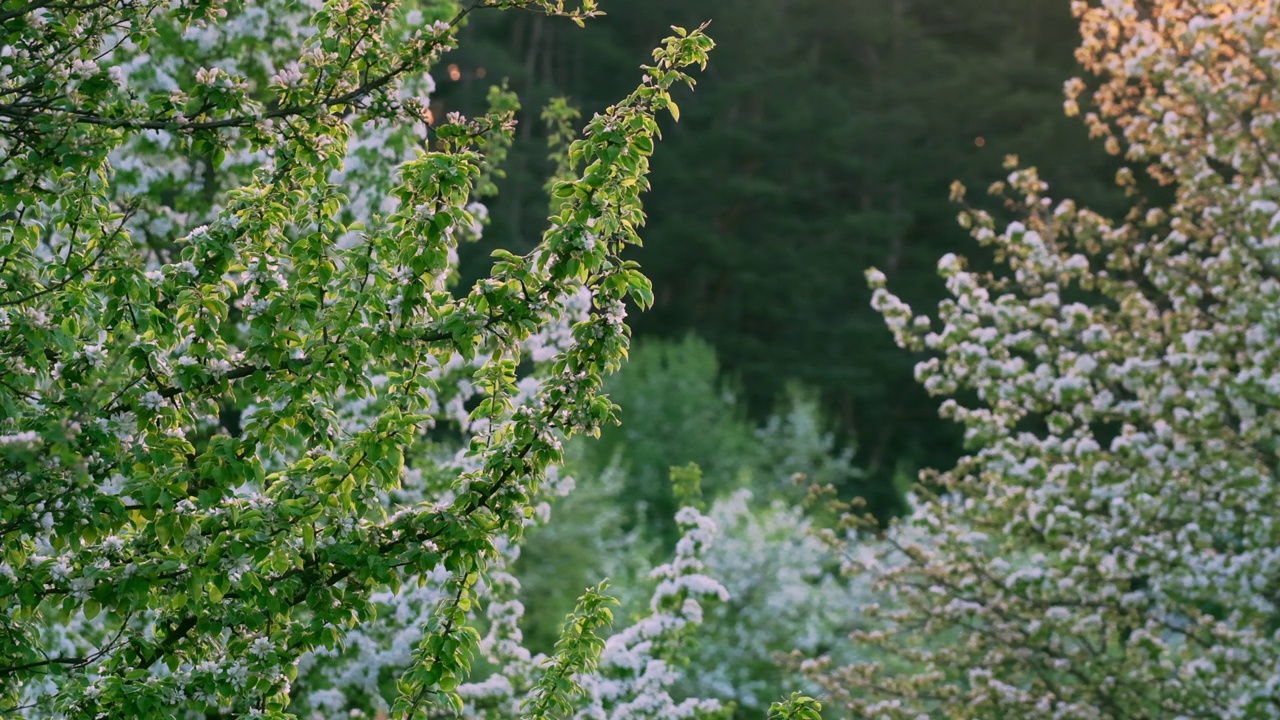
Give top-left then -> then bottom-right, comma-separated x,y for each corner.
810,0 -> 1280,720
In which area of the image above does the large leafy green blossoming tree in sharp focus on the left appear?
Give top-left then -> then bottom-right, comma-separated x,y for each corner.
0,0 -> 742,719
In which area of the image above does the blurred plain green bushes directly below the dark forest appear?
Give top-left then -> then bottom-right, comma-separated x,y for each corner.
572,336 -> 865,541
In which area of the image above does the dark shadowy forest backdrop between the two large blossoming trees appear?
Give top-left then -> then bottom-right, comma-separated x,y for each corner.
438,0 -> 1117,512
